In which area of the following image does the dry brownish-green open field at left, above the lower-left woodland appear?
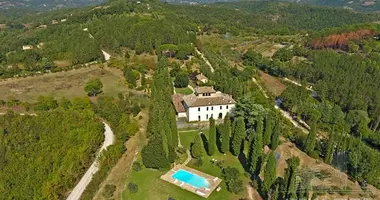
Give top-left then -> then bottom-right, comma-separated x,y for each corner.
0,66 -> 128,102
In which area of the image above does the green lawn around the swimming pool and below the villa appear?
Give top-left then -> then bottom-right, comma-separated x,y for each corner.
123,130 -> 249,200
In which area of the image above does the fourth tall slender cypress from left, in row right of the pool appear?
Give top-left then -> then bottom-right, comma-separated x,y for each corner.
249,127 -> 263,174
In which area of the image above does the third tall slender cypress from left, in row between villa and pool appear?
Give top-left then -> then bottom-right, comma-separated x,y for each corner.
231,117 -> 245,156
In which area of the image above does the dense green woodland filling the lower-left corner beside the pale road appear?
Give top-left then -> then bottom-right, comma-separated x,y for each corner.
0,109 -> 103,199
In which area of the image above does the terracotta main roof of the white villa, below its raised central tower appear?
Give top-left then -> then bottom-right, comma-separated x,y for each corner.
183,93 -> 236,107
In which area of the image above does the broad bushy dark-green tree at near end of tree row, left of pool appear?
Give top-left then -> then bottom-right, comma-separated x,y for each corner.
141,134 -> 169,169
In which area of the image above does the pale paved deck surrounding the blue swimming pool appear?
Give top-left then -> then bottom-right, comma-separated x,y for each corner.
161,165 -> 222,198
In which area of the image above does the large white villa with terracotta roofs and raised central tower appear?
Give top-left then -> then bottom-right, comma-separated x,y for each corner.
172,87 -> 236,122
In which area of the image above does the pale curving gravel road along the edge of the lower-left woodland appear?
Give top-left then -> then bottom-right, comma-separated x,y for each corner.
67,122 -> 115,200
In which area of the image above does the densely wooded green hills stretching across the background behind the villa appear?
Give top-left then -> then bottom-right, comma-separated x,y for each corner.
0,0 -> 377,78
